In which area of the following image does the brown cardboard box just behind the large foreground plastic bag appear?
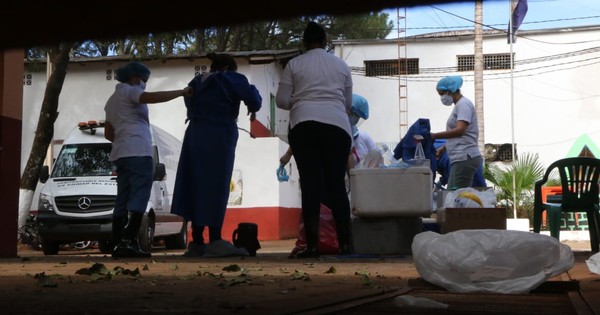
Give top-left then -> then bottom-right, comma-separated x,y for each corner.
437,208 -> 506,233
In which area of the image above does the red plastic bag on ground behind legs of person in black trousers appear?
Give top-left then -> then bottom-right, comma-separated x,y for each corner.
290,204 -> 340,257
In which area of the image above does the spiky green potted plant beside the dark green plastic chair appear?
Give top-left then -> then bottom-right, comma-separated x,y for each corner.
483,153 -> 546,219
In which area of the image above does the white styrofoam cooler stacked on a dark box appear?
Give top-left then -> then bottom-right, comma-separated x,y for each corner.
350,167 -> 433,217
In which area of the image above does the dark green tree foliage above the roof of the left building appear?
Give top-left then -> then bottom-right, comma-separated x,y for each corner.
27,12 -> 393,59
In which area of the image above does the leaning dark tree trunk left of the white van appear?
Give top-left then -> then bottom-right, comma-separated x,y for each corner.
19,43 -> 74,227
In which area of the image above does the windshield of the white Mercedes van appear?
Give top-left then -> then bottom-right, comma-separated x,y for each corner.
51,143 -> 116,177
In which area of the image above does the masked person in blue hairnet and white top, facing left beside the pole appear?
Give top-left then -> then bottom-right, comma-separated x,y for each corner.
431,76 -> 483,190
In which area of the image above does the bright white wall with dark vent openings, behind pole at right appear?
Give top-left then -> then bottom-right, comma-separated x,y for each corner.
335,26 -> 600,170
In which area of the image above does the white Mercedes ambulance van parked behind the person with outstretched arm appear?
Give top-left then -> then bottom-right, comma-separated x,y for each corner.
37,121 -> 187,255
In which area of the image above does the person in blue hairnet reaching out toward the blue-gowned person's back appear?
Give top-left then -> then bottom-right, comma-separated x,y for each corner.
104,62 -> 192,258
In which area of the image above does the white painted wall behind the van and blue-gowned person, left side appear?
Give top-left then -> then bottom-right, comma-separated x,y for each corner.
21,58 -> 300,211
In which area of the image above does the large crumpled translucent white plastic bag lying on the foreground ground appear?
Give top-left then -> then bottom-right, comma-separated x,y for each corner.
412,230 -> 574,294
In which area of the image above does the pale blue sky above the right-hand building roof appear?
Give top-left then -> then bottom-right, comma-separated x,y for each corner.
385,0 -> 600,38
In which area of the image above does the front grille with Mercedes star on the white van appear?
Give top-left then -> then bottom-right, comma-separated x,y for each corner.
54,195 -> 116,213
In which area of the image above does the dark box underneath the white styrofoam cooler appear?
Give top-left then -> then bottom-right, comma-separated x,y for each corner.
352,217 -> 423,255
